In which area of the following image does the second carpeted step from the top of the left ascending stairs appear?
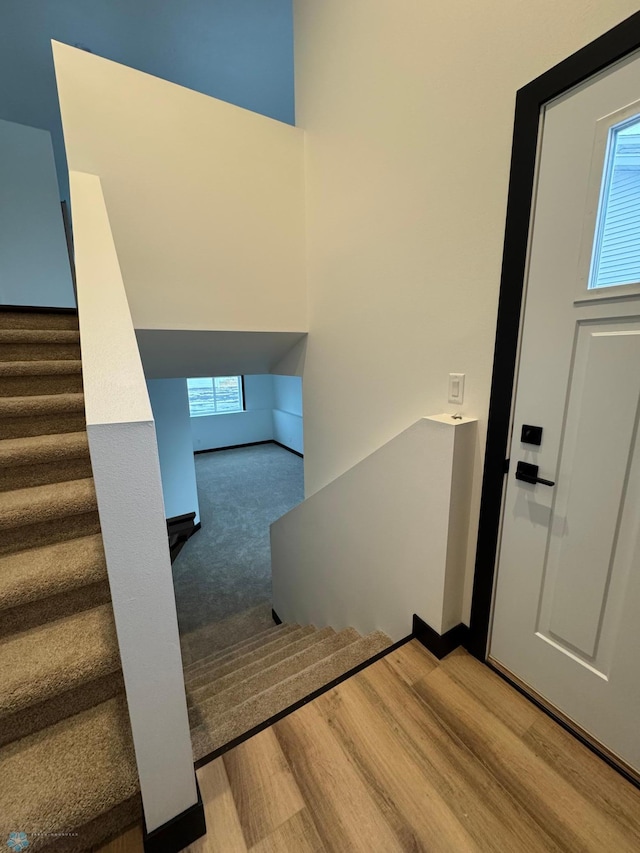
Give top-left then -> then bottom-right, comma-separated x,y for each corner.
0,359 -> 82,397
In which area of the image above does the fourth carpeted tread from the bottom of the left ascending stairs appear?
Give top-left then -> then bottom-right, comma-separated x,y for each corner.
0,477 -> 97,530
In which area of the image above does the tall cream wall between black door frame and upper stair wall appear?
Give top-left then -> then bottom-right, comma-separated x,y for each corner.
294,0 -> 638,619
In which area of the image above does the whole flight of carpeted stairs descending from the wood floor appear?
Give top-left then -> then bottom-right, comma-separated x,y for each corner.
185,624 -> 391,761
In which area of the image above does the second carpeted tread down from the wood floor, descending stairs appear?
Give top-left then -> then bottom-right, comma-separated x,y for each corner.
188,628 -> 360,721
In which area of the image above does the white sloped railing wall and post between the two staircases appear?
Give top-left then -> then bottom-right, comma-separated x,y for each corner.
70,171 -> 197,832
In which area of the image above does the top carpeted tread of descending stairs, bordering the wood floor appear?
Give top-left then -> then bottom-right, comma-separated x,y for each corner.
191,631 -> 391,761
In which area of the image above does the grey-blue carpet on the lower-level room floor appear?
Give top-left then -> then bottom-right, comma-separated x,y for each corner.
173,444 -> 304,644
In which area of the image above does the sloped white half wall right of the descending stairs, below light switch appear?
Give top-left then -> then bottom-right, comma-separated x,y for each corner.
271,415 -> 476,641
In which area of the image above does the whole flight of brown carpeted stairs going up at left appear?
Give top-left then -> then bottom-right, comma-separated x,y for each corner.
0,311 -> 142,853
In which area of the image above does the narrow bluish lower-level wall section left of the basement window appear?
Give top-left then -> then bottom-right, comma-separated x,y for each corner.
147,379 -> 200,524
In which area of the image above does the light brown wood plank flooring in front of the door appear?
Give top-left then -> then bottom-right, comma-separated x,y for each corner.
99,641 -> 640,853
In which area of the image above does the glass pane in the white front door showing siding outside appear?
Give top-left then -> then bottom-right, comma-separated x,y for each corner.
589,116 -> 640,289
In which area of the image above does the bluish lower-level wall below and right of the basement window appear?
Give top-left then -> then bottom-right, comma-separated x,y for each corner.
191,374 -> 273,450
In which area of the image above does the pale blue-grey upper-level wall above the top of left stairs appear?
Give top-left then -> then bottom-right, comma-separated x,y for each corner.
0,120 -> 76,308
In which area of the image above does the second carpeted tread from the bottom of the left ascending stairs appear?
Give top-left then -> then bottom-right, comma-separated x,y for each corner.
0,604 -> 120,718
